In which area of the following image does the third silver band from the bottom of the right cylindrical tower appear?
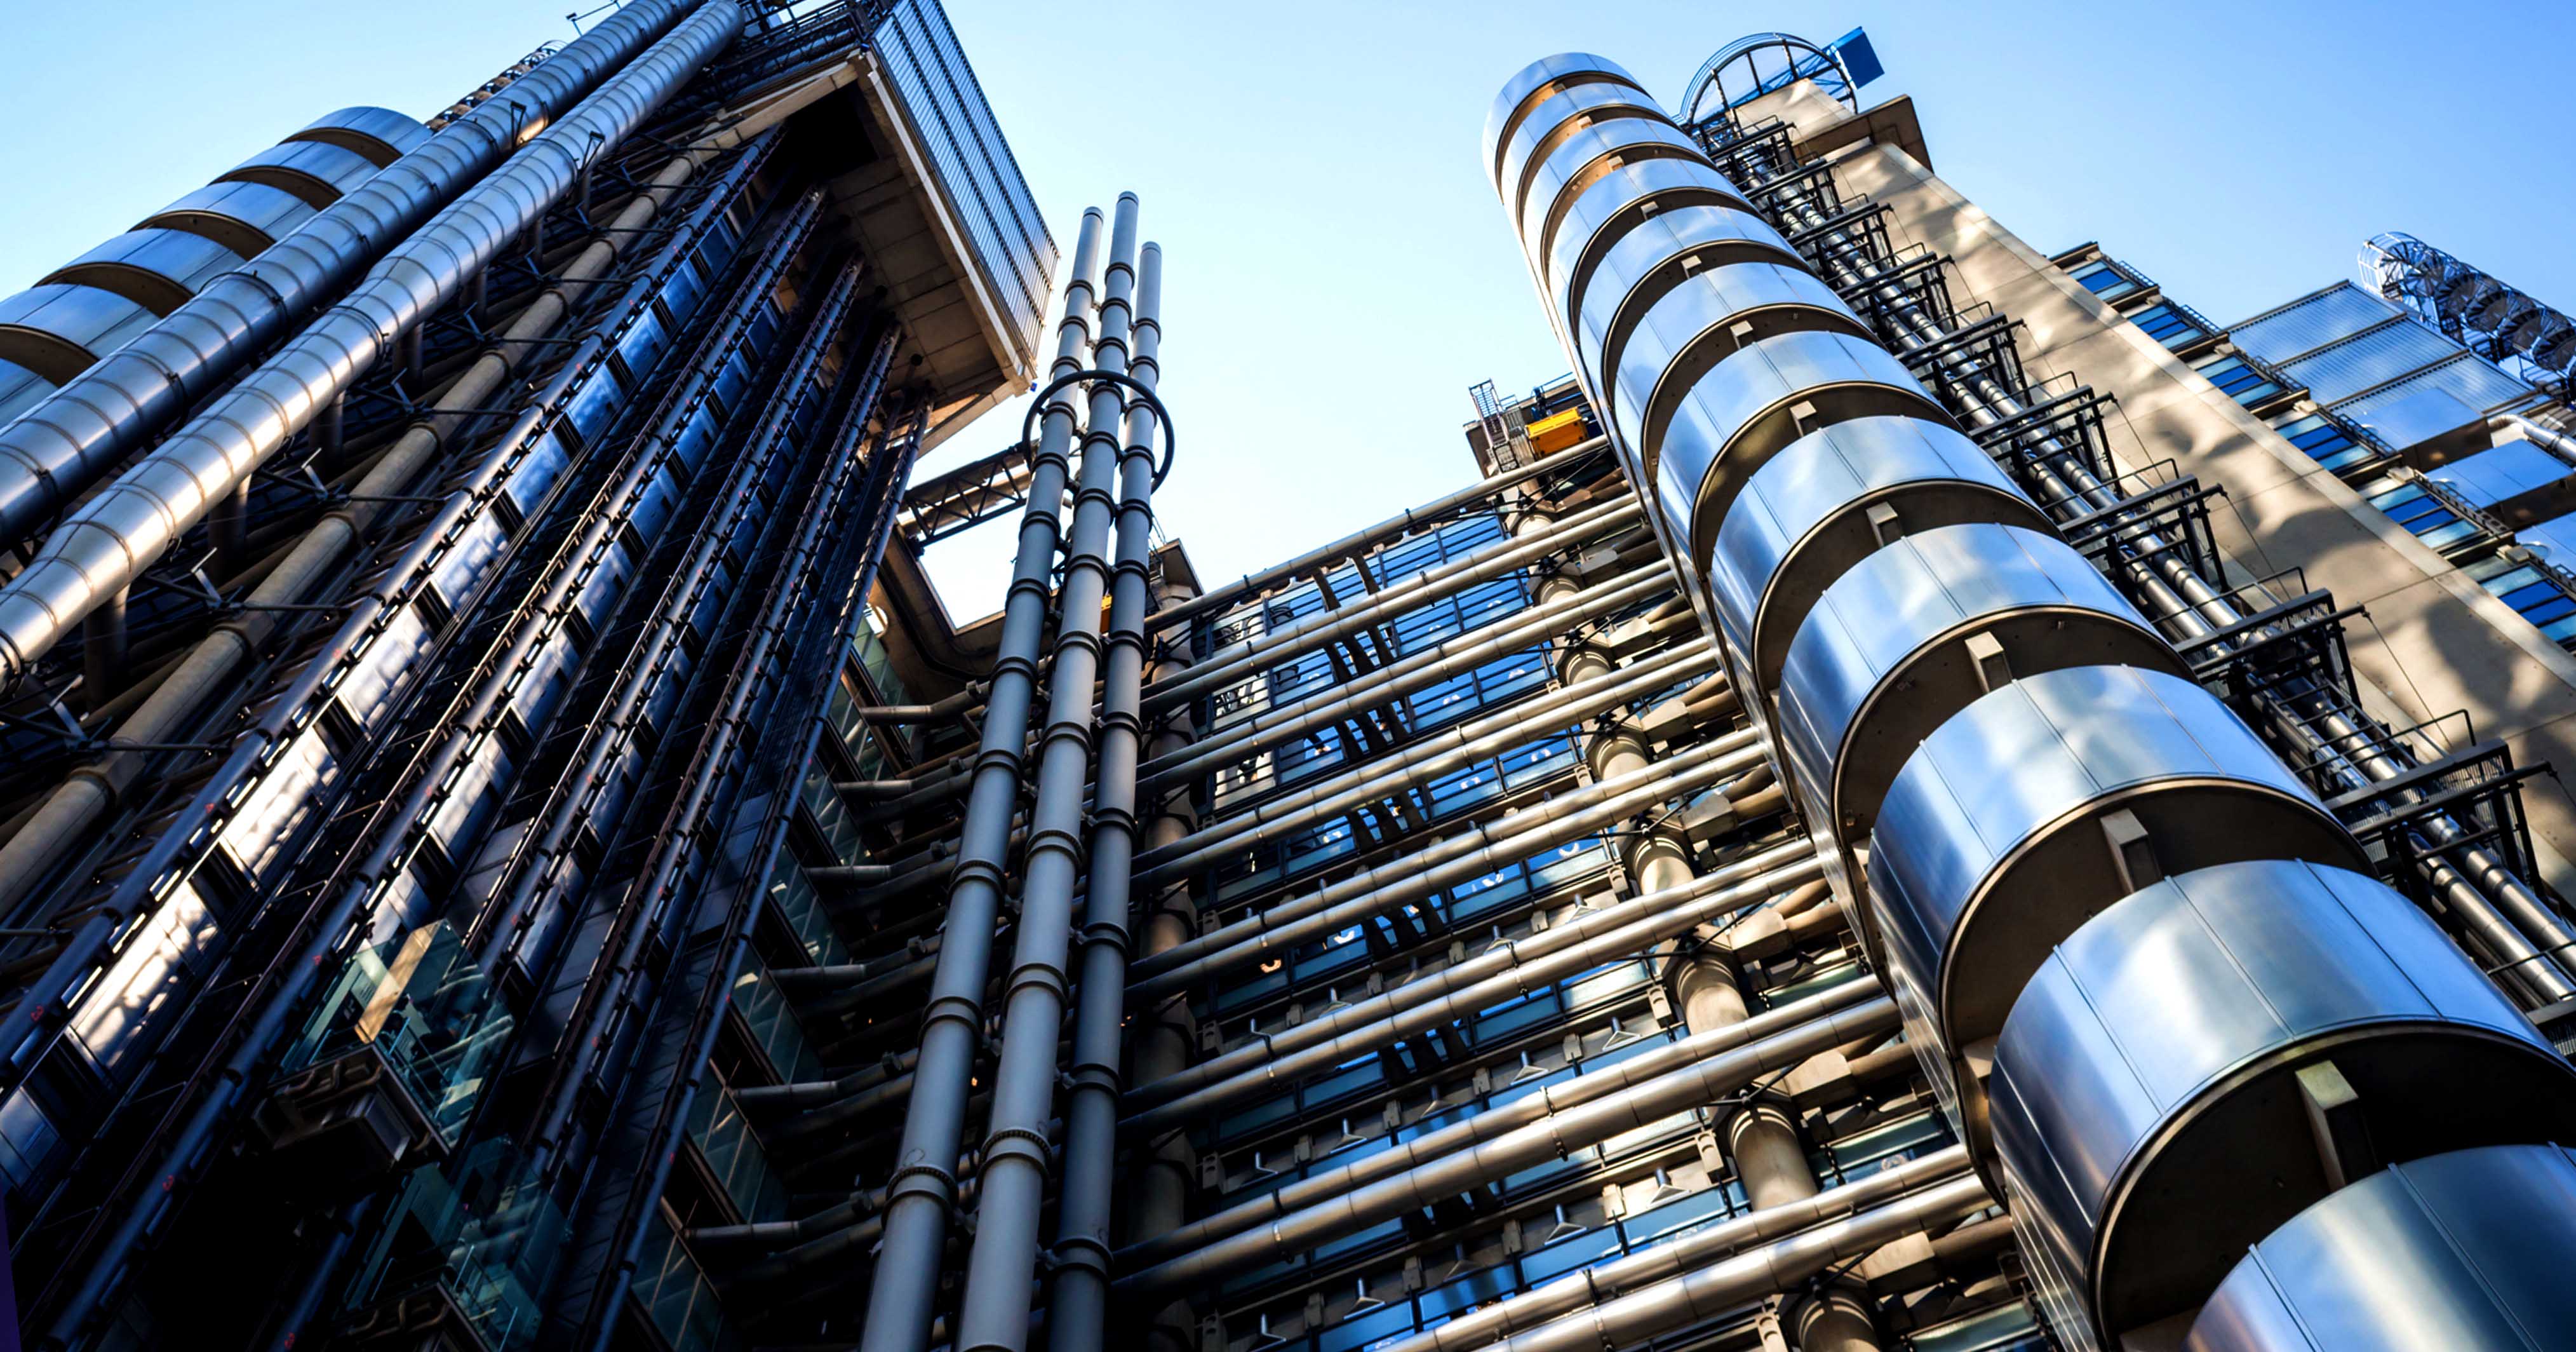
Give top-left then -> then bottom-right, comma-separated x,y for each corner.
1868,667 -> 2370,1118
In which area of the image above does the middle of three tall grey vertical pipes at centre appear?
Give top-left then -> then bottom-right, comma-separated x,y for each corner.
958,193 -> 1136,1352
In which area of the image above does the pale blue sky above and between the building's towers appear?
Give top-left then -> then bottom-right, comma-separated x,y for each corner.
0,0 -> 2576,613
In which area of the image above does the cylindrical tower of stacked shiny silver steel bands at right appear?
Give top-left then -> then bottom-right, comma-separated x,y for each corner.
1484,54 -> 2576,1352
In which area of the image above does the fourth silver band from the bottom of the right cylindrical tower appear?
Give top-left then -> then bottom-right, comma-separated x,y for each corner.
1778,522 -> 2190,842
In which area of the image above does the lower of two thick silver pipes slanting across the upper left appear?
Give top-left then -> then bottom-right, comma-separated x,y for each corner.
0,0 -> 739,685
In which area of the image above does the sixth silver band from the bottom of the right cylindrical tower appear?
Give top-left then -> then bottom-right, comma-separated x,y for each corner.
1639,330 -> 1950,569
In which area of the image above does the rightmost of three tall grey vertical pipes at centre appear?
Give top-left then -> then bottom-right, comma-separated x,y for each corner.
1040,234 -> 1162,1352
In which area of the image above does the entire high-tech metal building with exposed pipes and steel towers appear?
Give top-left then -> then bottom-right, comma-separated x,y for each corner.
0,10 -> 2576,1352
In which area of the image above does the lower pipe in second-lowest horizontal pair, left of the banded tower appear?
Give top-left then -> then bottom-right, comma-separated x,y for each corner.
1118,997 -> 1896,1292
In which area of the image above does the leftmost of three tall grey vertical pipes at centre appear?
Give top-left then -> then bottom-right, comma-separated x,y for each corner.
861,208 -> 1100,1352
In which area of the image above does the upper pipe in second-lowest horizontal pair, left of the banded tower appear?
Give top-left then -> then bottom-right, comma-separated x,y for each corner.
1118,981 -> 1912,1269
